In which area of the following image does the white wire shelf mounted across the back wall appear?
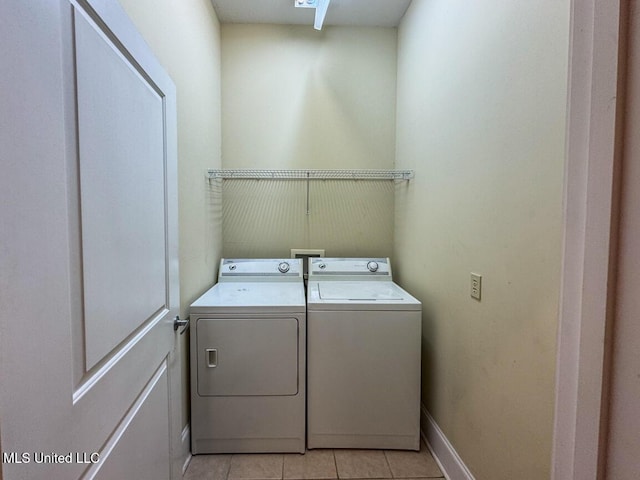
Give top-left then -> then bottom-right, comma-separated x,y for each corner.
207,169 -> 414,180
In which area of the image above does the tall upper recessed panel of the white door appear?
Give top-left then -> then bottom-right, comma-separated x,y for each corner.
74,9 -> 168,369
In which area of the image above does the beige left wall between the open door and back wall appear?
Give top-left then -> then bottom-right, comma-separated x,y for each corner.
120,0 -> 222,425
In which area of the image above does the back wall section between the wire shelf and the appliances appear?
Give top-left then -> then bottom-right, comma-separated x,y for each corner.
219,180 -> 394,258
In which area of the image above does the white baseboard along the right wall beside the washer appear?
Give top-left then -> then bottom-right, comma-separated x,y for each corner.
420,405 -> 475,480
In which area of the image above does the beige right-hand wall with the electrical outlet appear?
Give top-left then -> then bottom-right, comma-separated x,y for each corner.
394,0 -> 569,480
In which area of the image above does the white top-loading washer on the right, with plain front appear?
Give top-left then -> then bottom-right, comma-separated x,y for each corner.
307,258 -> 422,450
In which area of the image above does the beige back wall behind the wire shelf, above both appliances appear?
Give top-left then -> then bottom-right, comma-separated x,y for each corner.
222,25 -> 397,257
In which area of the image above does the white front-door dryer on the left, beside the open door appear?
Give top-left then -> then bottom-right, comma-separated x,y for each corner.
190,259 -> 306,454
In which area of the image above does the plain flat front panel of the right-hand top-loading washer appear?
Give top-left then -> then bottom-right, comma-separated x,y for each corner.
307,310 -> 421,450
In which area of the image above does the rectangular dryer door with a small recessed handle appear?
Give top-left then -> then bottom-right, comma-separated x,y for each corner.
196,318 -> 299,396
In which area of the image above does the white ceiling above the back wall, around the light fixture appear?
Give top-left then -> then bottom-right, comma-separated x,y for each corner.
211,0 -> 411,28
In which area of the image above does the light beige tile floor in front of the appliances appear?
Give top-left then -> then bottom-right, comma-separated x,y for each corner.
183,444 -> 444,480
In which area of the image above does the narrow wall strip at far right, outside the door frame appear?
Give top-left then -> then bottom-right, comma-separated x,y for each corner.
606,3 -> 640,480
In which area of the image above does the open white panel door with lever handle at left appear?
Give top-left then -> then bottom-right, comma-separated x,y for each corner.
0,0 -> 182,480
